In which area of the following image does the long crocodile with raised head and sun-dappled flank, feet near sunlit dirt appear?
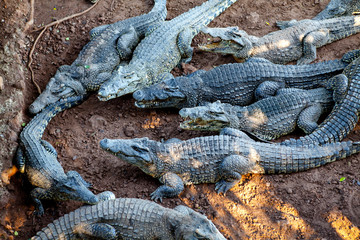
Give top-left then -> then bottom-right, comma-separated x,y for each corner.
100,128 -> 360,201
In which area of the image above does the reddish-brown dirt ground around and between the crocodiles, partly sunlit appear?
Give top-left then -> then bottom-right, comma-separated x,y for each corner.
0,0 -> 360,240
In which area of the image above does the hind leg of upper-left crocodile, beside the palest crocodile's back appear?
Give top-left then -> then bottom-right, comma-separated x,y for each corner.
117,26 -> 140,60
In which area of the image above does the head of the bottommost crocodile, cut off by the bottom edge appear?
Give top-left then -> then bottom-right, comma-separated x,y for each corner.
169,205 -> 226,240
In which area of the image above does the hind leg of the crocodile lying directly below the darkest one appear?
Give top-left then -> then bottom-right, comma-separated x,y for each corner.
297,103 -> 322,134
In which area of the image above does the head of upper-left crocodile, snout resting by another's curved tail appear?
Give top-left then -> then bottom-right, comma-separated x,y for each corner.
29,65 -> 86,114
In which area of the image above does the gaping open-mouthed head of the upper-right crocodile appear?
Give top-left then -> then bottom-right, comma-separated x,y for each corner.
199,27 -> 253,61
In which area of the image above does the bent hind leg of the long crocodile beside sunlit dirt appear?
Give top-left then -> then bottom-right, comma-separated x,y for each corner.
215,155 -> 255,194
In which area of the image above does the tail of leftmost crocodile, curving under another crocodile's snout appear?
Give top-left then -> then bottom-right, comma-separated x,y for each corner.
20,96 -> 85,138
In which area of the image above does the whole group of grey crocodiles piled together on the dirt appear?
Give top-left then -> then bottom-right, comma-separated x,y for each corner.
11,0 -> 360,240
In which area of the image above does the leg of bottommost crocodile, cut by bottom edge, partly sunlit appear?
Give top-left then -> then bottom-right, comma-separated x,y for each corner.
74,223 -> 117,239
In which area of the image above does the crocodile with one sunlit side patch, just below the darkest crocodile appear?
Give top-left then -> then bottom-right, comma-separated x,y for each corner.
179,88 -> 334,141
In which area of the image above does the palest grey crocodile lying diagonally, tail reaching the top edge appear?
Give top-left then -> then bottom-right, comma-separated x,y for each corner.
98,0 -> 237,101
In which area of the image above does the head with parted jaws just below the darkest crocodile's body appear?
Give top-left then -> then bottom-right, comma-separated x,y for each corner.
179,101 -> 237,131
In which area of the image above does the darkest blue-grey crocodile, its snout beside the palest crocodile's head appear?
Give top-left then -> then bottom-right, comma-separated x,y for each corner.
133,58 -> 351,108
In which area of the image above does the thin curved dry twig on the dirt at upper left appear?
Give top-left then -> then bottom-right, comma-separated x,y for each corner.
28,0 -> 101,94
